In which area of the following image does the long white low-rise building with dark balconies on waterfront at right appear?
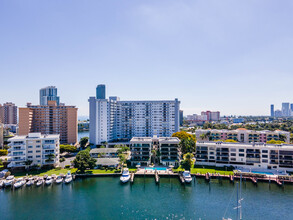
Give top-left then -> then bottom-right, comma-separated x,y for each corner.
196,141 -> 293,172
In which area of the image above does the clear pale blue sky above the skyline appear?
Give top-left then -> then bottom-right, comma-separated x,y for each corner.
0,0 -> 293,115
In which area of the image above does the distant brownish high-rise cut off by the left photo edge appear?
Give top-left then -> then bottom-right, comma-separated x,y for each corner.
0,102 -> 17,124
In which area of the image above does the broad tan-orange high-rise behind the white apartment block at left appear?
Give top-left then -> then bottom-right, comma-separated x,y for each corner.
19,101 -> 77,144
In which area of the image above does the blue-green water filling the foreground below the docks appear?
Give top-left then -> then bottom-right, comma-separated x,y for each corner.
0,177 -> 293,220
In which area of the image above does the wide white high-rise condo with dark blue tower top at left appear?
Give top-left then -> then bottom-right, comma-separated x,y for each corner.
89,86 -> 180,145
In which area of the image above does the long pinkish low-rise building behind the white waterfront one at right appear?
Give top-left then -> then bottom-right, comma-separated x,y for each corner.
195,128 -> 290,143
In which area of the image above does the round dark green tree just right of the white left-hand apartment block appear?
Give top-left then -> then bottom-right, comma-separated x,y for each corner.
73,150 -> 97,173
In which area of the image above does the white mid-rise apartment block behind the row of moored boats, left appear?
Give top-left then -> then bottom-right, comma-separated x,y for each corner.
8,133 -> 60,168
